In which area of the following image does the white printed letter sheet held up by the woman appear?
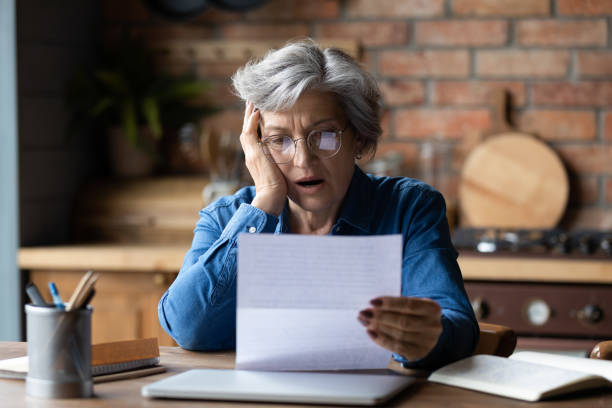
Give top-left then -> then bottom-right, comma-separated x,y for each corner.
236,234 -> 402,370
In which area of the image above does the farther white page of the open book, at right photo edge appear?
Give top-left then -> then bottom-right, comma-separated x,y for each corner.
510,351 -> 612,381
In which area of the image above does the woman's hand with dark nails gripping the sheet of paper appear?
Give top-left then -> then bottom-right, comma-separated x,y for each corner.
357,296 -> 442,361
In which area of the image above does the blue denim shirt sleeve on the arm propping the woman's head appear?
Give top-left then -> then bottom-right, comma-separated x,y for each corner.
158,203 -> 278,350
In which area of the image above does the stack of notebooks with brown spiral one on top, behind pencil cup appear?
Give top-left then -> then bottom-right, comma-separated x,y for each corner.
0,337 -> 165,383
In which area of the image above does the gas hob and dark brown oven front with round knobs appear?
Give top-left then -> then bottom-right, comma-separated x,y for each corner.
452,228 -> 612,354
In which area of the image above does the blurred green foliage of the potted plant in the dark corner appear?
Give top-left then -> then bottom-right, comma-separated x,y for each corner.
66,38 -> 214,144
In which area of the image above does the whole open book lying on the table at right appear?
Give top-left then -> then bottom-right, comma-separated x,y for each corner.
429,351 -> 612,401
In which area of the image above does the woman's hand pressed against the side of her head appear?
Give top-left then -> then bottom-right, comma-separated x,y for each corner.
240,102 -> 287,216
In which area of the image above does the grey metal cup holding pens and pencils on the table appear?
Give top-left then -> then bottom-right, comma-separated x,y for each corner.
25,305 -> 93,398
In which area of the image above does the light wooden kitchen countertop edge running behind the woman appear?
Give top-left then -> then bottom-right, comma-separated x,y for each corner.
19,244 -> 612,284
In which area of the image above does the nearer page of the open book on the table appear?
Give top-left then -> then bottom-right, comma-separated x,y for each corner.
429,355 -> 605,401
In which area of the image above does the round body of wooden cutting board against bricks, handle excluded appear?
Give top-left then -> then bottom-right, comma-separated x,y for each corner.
459,132 -> 569,229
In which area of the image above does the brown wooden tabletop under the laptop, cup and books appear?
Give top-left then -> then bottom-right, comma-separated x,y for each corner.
0,342 -> 612,408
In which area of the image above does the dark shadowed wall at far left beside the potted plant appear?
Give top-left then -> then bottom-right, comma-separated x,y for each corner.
15,0 -> 101,246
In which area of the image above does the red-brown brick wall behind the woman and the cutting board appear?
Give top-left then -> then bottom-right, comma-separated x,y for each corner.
104,0 -> 612,229
